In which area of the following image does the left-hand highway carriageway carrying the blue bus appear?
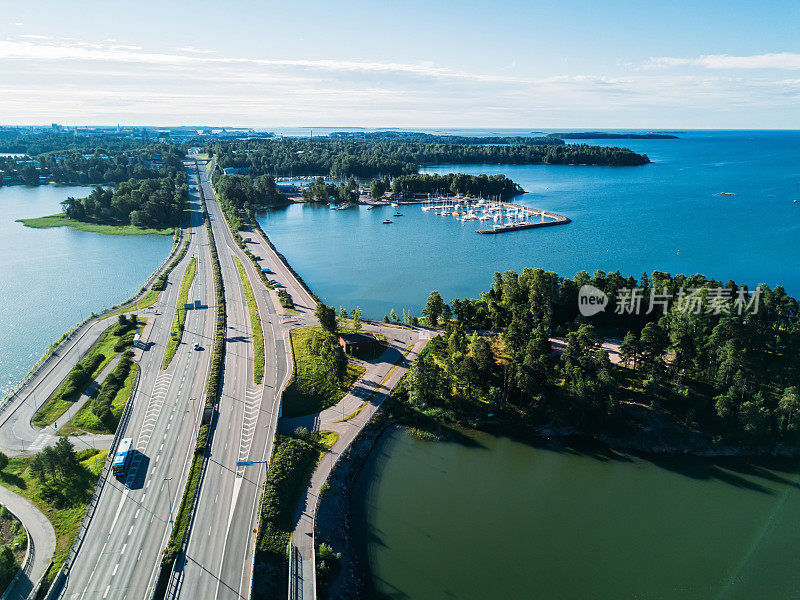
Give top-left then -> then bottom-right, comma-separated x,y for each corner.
62,165 -> 214,600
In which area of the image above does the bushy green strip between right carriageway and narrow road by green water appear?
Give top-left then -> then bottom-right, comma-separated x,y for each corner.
253,431 -> 339,597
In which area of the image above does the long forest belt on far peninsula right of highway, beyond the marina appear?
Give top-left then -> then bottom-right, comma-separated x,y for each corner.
208,138 -> 650,178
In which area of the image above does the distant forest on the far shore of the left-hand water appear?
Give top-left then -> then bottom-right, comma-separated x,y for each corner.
0,144 -> 184,185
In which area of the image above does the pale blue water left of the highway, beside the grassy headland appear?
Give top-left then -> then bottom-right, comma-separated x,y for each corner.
0,185 -> 172,396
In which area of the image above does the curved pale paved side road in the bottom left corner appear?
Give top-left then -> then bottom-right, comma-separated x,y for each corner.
0,487 -> 56,600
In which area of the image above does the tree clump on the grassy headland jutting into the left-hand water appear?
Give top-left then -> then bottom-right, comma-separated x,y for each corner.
61,176 -> 188,229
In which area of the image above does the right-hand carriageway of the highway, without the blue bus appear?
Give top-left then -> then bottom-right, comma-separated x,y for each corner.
175,162 -> 289,600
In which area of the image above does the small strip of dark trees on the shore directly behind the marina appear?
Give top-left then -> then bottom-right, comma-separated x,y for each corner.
392,173 -> 524,199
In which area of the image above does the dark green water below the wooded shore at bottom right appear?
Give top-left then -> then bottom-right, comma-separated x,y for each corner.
354,431 -> 800,600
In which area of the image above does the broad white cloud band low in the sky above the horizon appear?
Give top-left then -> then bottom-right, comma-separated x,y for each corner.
0,36 -> 800,127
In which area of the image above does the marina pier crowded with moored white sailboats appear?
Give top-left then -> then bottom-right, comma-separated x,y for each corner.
421,196 -> 572,235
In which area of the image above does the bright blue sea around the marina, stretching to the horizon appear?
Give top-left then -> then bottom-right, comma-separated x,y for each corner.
259,131 -> 800,318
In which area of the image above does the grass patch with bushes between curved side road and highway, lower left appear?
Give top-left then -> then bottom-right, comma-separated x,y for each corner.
0,449 -> 108,579
